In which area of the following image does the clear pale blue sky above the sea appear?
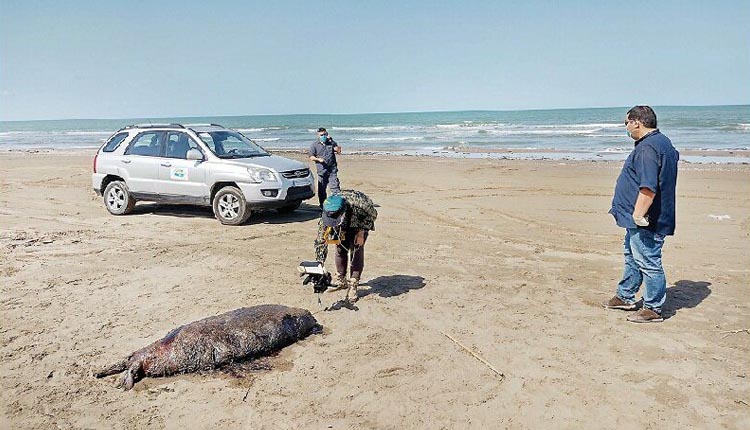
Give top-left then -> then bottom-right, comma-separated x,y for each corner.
0,0 -> 750,120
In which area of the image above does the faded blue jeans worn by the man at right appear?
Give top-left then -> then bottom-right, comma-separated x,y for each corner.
617,228 -> 667,313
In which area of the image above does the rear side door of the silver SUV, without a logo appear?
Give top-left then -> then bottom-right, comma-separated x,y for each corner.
122,131 -> 165,194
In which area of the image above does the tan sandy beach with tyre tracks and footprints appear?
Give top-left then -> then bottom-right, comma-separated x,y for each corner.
0,153 -> 750,429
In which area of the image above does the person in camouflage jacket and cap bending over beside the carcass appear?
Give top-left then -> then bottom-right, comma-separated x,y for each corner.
315,190 -> 378,303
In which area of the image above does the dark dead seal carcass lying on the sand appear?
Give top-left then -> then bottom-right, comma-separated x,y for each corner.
94,305 -> 317,390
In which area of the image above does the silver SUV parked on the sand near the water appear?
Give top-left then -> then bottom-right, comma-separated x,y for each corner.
91,124 -> 315,225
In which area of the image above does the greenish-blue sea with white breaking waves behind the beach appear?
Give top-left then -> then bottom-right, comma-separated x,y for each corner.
0,105 -> 750,163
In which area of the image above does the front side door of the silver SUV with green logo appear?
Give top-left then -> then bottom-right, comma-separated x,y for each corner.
156,131 -> 209,204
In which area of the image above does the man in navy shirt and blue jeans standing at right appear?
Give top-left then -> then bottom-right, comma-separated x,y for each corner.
603,106 -> 680,323
